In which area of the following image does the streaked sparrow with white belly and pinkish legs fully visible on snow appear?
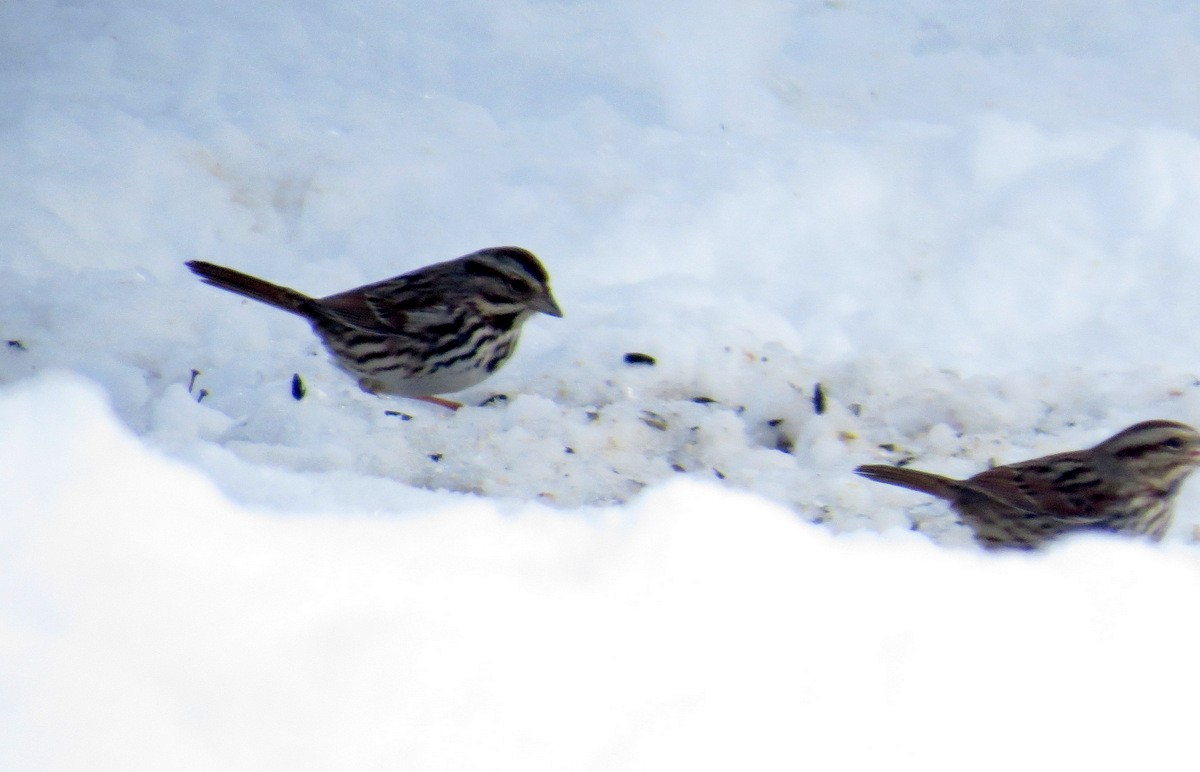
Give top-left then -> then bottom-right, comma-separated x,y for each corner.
187,246 -> 563,408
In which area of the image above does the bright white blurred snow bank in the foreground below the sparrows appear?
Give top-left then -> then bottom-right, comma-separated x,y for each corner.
0,375 -> 1200,770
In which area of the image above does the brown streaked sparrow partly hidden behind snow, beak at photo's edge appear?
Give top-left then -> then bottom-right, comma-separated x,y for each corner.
856,420 -> 1200,549
